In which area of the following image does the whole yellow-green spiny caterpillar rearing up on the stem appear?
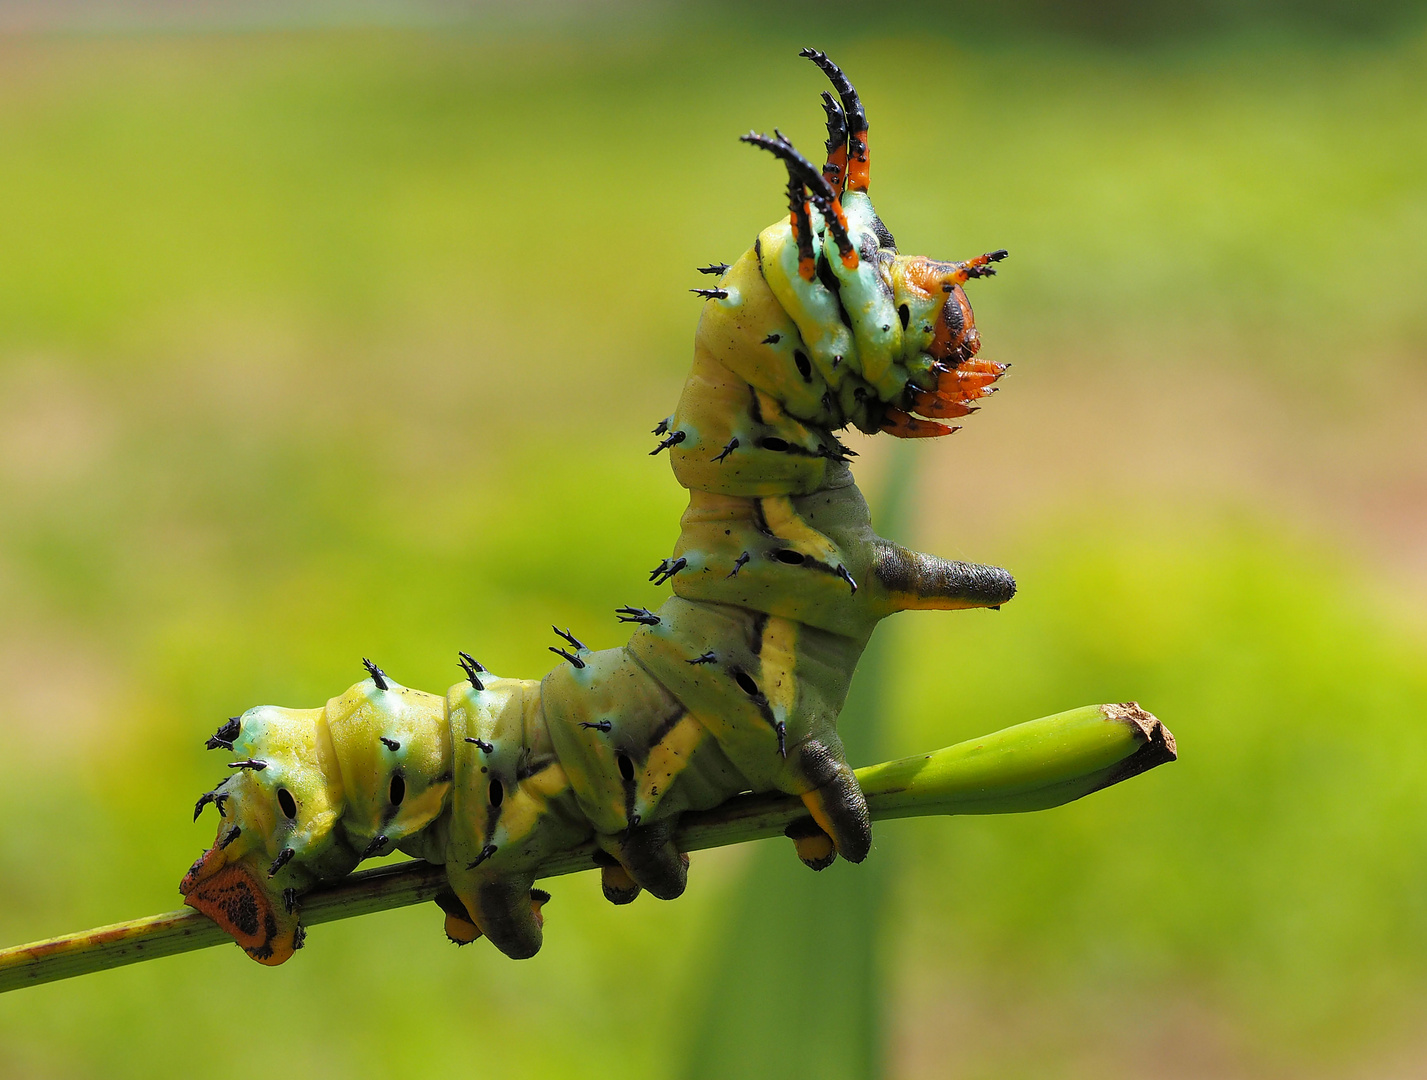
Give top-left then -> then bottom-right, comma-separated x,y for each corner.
180,49 -> 1016,964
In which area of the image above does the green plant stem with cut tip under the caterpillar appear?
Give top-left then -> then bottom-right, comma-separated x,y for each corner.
0,705 -> 1174,993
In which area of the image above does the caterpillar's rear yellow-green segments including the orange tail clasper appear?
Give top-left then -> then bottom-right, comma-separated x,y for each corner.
178,668 -> 451,964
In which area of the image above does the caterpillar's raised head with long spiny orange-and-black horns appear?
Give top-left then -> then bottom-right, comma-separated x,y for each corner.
743,49 -> 1006,438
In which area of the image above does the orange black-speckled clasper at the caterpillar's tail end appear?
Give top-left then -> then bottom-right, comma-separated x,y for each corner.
178,845 -> 304,967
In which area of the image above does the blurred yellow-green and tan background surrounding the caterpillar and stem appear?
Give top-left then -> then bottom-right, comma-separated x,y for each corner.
0,0 -> 1427,1080
